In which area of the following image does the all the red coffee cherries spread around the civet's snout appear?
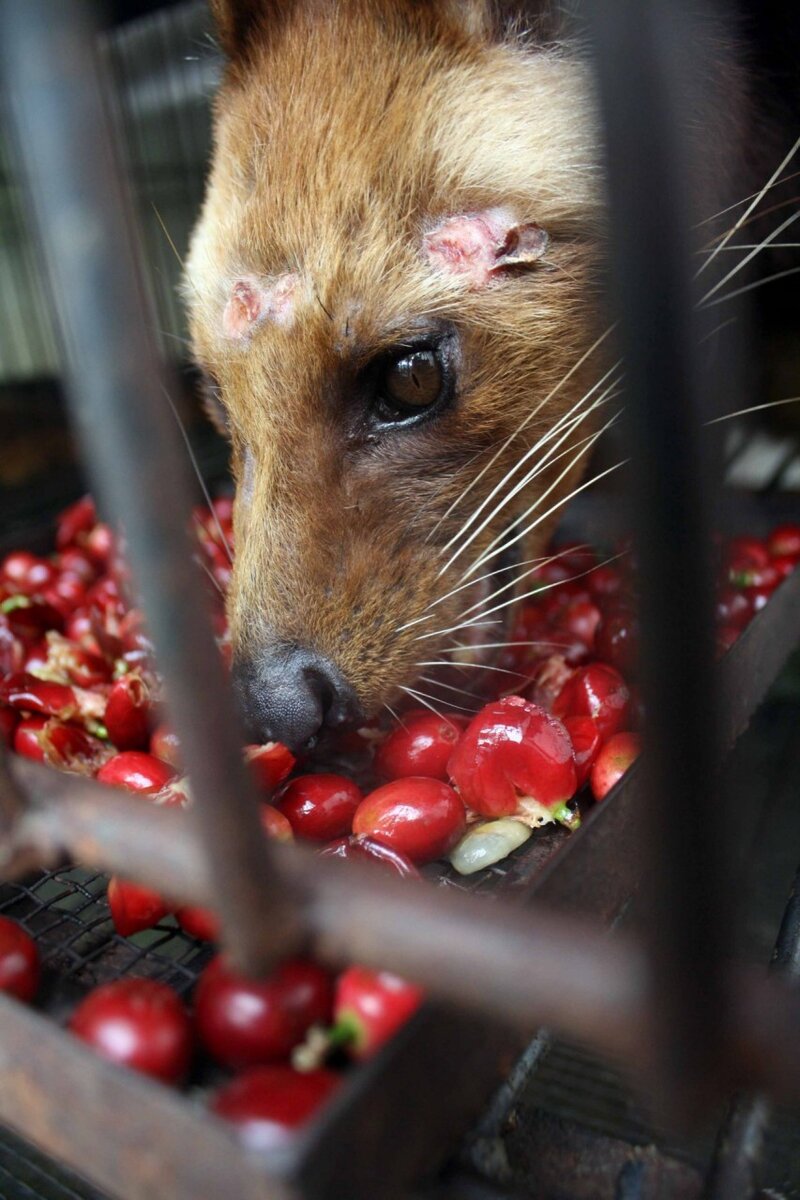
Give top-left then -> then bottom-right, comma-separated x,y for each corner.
0,497 -> 800,1147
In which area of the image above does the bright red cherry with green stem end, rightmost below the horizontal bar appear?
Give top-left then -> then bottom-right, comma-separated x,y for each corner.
333,966 -> 425,1058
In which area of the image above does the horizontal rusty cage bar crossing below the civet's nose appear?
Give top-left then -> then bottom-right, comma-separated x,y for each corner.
4,760 -> 800,1094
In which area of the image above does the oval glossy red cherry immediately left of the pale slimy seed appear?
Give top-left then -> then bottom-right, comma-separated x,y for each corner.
353,776 -> 467,863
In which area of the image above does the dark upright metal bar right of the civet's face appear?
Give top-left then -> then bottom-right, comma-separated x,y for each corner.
585,0 -> 729,1116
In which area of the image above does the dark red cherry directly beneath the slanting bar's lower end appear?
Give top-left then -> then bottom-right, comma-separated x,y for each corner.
194,955 -> 333,1068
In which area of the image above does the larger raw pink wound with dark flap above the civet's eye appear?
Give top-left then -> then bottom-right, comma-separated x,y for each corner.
422,209 -> 549,290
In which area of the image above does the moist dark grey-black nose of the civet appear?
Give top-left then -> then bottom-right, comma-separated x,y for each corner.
233,643 -> 363,750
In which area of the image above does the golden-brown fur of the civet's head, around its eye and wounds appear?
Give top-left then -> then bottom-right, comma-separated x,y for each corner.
186,0 -> 602,713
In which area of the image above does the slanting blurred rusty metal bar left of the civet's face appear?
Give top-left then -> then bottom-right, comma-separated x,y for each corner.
0,0 -> 300,971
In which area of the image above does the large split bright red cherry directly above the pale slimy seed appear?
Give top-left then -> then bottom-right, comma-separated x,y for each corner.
449,696 -> 577,817
